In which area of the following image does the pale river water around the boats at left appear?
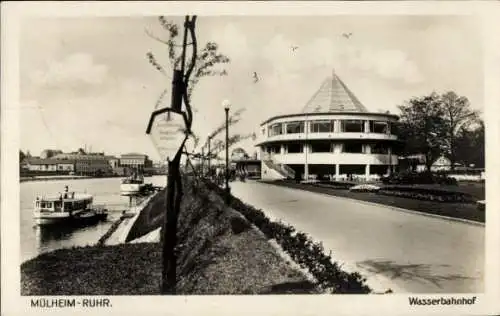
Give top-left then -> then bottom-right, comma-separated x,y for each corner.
20,176 -> 166,262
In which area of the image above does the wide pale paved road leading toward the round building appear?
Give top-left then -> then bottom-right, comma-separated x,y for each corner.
231,181 -> 485,293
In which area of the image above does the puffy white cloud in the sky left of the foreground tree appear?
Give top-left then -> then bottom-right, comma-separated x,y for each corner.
30,53 -> 108,87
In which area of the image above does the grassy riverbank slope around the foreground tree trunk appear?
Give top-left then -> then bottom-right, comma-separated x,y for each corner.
21,179 -> 318,295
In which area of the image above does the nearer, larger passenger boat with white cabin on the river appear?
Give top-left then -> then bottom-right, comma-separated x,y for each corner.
33,187 -> 108,225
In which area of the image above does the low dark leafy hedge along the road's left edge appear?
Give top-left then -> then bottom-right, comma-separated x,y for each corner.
203,182 -> 371,294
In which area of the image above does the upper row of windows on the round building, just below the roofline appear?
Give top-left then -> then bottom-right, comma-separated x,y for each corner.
268,120 -> 391,136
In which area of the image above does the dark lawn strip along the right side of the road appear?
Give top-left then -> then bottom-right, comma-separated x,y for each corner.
263,181 -> 485,223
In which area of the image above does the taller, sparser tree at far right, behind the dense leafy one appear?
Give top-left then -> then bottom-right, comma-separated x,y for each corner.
440,91 -> 479,170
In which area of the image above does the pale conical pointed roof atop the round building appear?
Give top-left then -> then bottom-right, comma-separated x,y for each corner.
302,71 -> 368,113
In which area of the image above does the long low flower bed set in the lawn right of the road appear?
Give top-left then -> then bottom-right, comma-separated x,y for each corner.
378,186 -> 474,203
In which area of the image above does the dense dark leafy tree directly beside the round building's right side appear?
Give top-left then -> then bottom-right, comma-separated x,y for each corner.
398,93 -> 444,171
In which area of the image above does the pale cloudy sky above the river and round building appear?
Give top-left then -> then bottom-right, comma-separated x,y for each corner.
19,15 -> 484,160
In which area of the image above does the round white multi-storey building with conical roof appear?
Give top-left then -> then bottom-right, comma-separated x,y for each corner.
257,71 -> 399,180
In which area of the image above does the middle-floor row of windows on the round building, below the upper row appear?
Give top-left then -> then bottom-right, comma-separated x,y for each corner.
266,142 -> 389,155
